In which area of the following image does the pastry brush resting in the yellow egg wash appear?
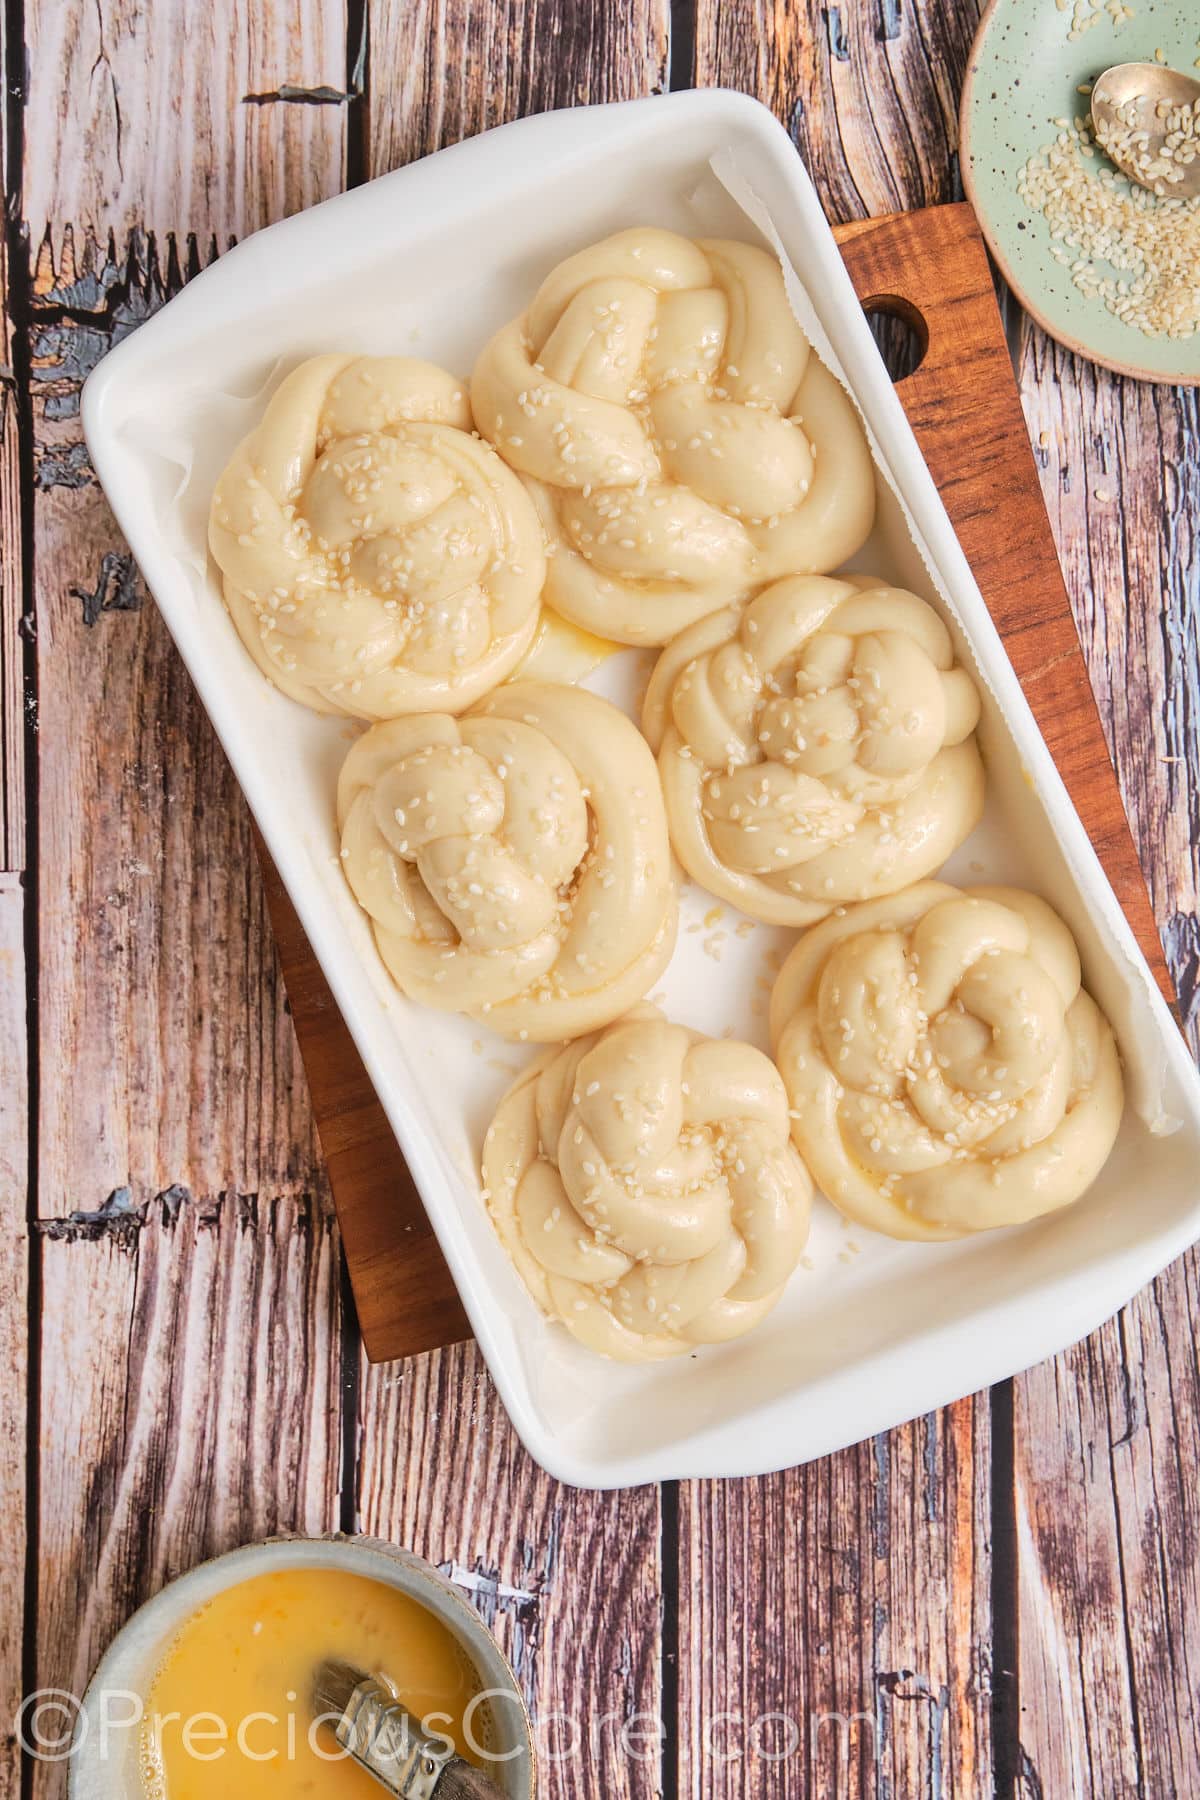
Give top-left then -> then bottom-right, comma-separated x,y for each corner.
313,1661 -> 504,1800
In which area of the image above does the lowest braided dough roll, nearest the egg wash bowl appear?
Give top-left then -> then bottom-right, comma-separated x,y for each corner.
484,1006 -> 813,1363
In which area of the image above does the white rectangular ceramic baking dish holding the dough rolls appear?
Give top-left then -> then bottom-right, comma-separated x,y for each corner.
83,92 -> 1200,1487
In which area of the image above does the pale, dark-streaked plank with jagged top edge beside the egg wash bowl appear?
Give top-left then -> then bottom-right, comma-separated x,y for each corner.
34,1190 -> 342,1756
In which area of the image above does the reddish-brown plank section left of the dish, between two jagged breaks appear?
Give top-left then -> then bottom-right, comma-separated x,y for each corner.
34,486 -> 332,1217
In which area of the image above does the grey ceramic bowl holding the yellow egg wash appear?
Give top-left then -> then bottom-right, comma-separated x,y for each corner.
67,1537 -> 536,1800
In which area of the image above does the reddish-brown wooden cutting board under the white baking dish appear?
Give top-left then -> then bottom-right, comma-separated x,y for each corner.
259,205 -> 1173,1363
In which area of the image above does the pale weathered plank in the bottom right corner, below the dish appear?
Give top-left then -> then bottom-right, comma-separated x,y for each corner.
1015,1256 -> 1200,1800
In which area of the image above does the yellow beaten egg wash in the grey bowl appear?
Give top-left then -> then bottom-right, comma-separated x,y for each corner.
142,1568 -> 486,1800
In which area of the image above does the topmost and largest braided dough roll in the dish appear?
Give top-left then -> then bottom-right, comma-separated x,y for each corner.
471,229 -> 874,644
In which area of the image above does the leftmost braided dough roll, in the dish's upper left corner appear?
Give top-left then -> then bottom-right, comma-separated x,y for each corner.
209,356 -> 545,718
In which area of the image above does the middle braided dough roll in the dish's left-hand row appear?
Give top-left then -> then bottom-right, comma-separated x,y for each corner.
338,682 -> 676,1042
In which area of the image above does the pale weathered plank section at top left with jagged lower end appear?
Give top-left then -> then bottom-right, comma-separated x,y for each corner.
25,0 -> 345,265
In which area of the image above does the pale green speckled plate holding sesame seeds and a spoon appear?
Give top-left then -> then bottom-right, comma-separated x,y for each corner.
959,0 -> 1200,385
